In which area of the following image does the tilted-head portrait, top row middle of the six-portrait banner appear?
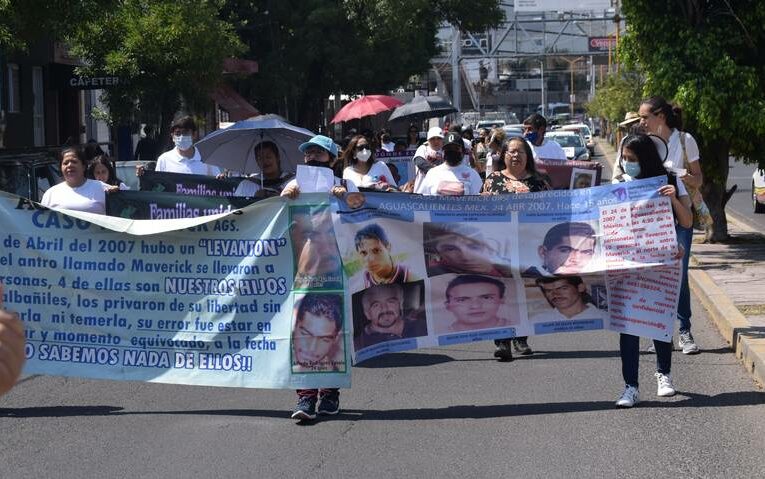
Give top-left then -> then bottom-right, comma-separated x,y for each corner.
423,223 -> 513,278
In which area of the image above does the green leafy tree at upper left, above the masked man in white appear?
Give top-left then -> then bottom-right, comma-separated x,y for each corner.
66,0 -> 244,143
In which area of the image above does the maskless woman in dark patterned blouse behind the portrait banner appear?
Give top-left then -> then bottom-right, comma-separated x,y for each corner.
481,136 -> 552,361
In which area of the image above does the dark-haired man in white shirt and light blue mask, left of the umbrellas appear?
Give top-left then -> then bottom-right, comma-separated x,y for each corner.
136,116 -> 222,177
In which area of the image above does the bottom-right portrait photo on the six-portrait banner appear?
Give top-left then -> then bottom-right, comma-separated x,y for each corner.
526,275 -> 608,323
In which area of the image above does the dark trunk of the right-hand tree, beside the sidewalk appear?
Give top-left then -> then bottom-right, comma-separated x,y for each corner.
700,141 -> 730,243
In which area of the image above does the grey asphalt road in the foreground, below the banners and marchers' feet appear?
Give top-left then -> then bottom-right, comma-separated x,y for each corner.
0,296 -> 765,478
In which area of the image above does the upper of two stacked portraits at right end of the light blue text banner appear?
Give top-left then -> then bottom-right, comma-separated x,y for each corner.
290,206 -> 343,289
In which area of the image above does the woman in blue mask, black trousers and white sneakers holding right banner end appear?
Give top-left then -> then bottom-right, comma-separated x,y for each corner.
616,134 -> 693,407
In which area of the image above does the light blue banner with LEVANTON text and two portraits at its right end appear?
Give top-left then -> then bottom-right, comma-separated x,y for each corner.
0,193 -> 351,389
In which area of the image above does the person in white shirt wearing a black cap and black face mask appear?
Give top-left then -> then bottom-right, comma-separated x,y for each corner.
415,132 -> 483,196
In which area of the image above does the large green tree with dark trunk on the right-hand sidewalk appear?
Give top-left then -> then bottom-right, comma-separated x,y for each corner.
619,0 -> 765,241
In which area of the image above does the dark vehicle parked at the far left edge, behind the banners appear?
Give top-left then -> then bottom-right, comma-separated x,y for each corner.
0,150 -> 63,202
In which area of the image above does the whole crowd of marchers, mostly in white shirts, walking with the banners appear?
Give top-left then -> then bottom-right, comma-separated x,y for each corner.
0,97 -> 703,420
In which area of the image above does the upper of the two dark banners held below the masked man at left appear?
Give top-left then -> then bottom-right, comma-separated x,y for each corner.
139,170 -> 244,197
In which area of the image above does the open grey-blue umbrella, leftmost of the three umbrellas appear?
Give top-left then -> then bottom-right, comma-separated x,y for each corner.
200,115 -> 314,175
